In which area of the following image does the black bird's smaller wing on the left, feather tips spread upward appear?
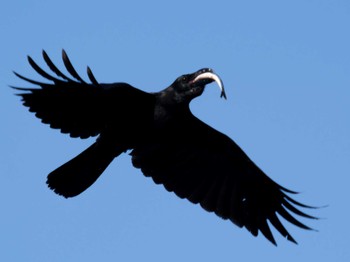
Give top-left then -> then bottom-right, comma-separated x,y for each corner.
14,50 -> 151,138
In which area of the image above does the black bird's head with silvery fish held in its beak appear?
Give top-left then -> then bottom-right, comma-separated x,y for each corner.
163,68 -> 226,106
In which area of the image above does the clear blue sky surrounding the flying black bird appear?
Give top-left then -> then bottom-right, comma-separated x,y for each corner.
0,0 -> 350,262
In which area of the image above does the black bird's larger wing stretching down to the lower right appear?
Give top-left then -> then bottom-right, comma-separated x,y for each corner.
131,117 -> 315,245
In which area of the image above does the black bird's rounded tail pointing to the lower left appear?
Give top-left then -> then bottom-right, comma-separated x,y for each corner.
46,142 -> 124,198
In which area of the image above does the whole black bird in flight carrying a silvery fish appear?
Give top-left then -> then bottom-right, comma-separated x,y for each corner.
14,50 -> 316,245
